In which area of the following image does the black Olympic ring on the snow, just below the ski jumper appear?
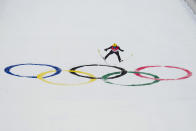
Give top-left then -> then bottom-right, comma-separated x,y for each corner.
70,64 -> 127,79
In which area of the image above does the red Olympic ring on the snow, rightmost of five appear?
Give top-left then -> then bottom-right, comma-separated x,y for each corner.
135,66 -> 192,81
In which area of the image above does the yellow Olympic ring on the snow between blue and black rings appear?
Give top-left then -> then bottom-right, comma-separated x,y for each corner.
37,70 -> 96,86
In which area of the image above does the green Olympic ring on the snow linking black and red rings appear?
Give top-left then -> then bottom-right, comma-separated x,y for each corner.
102,71 -> 160,86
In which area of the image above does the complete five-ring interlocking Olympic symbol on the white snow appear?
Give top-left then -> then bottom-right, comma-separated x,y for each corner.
4,63 -> 192,86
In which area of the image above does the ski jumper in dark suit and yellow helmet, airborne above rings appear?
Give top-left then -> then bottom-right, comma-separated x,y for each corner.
104,43 -> 124,62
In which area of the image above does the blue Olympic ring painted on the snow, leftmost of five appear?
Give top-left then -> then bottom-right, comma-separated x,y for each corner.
4,63 -> 62,78
